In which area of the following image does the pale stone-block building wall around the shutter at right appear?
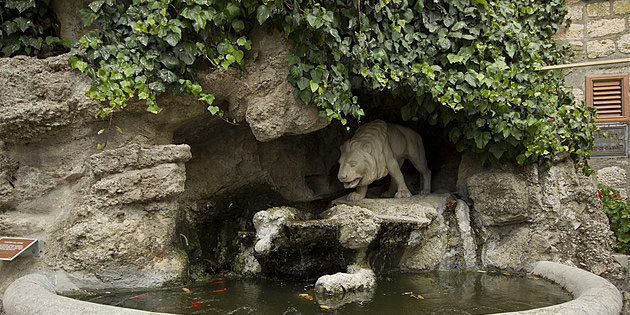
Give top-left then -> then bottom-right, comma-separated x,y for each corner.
556,0 -> 630,196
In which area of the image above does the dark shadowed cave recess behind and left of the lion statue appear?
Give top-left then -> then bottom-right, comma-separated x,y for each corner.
173,102 -> 461,281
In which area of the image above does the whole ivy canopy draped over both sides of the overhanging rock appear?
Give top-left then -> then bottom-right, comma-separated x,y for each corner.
64,0 -> 595,164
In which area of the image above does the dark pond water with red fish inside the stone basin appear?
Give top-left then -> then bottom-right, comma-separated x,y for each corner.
72,272 -> 572,315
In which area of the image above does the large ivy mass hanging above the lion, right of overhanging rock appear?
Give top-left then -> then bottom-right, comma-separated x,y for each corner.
272,0 -> 596,168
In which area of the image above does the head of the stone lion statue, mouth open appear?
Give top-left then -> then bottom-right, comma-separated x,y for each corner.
337,141 -> 379,188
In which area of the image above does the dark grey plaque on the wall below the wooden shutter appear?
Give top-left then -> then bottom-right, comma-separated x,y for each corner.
591,123 -> 628,157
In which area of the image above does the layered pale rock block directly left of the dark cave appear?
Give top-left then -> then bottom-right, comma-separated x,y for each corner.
55,144 -> 190,285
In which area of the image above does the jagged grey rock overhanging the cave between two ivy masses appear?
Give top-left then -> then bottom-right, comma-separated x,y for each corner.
199,29 -> 330,141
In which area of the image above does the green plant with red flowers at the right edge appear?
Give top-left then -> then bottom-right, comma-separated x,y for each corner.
597,184 -> 630,254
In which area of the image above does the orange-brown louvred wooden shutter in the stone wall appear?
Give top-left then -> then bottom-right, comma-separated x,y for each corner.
586,74 -> 630,122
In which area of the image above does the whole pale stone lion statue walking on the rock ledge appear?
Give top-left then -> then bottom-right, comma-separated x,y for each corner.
337,120 -> 431,201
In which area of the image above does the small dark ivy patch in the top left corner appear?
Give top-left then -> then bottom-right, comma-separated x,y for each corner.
0,0 -> 68,57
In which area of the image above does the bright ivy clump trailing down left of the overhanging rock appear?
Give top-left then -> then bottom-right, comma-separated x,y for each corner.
70,0 -> 258,117
